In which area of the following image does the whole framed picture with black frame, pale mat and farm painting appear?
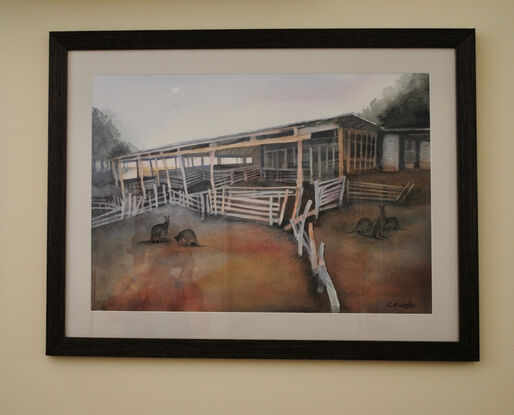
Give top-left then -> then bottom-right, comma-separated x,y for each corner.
46,29 -> 479,361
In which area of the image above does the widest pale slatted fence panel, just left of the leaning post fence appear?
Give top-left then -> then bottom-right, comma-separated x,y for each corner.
207,187 -> 294,225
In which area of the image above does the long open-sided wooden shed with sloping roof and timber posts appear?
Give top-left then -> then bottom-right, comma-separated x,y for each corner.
111,113 -> 381,195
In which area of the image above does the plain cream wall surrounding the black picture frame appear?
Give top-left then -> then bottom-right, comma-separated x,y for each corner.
0,0 -> 514,415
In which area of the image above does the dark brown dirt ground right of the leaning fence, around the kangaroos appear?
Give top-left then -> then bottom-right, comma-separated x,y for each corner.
314,170 -> 432,313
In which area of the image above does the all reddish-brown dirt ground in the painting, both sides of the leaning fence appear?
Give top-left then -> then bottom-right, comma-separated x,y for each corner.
92,170 -> 432,313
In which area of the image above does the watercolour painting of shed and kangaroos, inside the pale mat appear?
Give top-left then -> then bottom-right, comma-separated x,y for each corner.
91,73 -> 433,314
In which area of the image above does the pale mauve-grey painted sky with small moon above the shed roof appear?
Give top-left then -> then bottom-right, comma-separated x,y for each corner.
93,74 -> 402,150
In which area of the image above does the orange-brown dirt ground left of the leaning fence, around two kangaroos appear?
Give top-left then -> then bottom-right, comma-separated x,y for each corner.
92,206 -> 320,312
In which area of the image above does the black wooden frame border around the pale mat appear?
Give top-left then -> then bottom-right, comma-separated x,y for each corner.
46,29 -> 479,361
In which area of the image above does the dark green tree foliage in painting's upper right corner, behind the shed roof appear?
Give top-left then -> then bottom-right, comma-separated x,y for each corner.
361,74 -> 430,128
